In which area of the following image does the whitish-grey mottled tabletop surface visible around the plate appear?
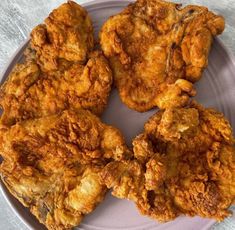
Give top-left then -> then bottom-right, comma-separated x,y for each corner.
0,0 -> 235,230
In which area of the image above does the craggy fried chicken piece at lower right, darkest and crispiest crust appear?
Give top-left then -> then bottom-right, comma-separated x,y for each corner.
100,102 -> 235,222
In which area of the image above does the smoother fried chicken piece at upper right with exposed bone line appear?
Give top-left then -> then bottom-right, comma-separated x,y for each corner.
100,0 -> 224,112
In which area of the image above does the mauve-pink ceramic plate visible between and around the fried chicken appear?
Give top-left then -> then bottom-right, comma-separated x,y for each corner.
2,0 -> 235,230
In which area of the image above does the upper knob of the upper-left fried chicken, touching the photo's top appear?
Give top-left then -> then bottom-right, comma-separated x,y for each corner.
31,1 -> 94,71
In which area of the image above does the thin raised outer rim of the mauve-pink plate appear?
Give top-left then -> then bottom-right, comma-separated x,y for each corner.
0,0 -> 235,230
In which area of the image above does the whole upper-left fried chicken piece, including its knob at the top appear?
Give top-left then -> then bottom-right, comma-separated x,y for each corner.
0,1 -> 112,125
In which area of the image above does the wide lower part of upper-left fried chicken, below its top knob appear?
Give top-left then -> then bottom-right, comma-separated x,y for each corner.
0,51 -> 112,125
